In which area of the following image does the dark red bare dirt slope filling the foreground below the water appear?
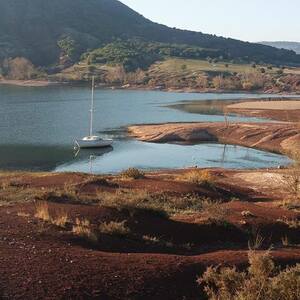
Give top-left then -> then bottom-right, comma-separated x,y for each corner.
0,169 -> 300,300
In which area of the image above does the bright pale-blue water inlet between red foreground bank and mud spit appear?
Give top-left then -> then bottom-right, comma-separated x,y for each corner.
55,140 -> 289,174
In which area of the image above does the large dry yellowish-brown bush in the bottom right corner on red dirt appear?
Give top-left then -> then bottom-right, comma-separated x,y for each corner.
198,251 -> 300,300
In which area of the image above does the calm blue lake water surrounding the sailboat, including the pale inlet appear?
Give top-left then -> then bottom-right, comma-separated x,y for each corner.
0,86 -> 292,173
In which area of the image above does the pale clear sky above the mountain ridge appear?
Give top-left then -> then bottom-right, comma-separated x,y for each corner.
121,0 -> 300,42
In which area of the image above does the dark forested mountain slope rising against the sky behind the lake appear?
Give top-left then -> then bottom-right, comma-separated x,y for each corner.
0,0 -> 300,65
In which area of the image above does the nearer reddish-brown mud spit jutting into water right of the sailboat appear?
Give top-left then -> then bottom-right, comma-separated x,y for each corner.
128,122 -> 300,153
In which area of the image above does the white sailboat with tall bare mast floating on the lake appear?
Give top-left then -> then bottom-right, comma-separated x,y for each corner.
75,76 -> 113,148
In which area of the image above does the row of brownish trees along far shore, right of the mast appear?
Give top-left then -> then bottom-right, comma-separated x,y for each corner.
92,66 -> 300,91
